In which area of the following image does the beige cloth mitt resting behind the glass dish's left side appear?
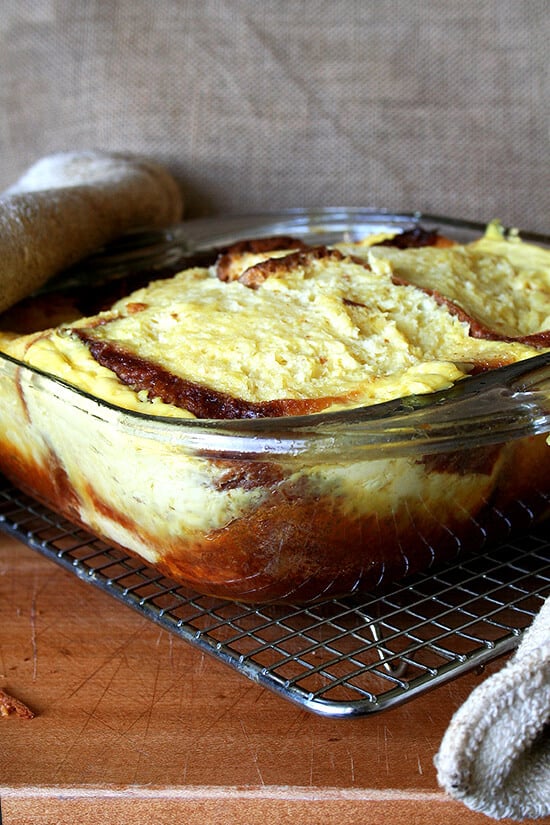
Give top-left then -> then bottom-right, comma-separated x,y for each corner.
0,151 -> 183,312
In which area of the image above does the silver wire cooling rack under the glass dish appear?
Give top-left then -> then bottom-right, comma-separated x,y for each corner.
0,477 -> 550,717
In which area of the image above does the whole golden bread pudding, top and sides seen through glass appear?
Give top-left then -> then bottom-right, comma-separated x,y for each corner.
0,211 -> 550,602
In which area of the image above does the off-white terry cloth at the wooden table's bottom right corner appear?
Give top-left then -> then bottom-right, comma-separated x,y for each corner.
435,598 -> 550,820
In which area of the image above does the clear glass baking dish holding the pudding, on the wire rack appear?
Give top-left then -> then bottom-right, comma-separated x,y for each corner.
0,209 -> 550,603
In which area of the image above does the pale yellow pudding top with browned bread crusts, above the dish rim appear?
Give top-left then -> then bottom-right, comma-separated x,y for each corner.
5,230 -> 550,418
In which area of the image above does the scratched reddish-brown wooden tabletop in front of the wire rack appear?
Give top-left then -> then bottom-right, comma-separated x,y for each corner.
0,533 -> 540,825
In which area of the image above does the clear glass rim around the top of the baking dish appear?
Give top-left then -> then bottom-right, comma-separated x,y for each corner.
4,207 -> 550,461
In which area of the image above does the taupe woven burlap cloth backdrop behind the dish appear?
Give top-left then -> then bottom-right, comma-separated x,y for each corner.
0,0 -> 550,232
